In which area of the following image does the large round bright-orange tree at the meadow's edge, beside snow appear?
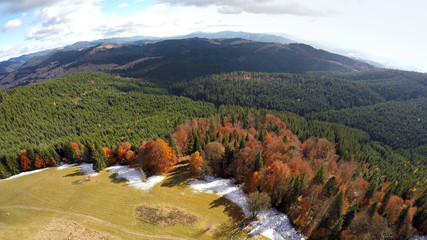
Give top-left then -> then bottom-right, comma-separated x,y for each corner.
137,138 -> 176,175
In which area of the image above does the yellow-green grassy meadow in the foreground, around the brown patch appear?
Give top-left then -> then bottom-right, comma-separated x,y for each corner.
0,167 -> 251,240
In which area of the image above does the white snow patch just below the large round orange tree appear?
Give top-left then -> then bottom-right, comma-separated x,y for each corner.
107,165 -> 165,191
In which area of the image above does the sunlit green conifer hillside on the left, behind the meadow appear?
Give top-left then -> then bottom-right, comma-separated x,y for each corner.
0,73 -> 215,153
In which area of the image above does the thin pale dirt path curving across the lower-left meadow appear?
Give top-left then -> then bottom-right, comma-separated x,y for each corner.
0,205 -> 186,240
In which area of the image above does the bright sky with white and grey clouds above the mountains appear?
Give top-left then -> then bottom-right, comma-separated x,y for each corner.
0,0 -> 427,72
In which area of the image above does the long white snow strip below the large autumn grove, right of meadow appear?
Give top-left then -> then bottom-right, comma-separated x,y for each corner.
190,177 -> 305,240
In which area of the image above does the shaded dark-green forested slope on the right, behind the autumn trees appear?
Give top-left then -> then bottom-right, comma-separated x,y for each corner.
170,70 -> 427,149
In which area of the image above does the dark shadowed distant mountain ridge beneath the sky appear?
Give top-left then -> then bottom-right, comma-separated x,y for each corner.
0,35 -> 374,88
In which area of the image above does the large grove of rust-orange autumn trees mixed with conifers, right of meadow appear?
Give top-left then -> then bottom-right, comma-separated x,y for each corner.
173,114 -> 427,239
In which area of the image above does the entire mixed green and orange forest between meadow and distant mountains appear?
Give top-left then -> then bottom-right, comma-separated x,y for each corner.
0,71 -> 427,239
